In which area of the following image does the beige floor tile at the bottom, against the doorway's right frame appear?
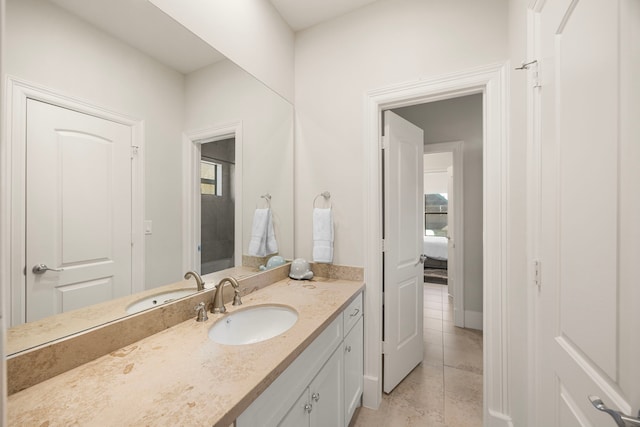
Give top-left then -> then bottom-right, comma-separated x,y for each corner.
444,366 -> 482,427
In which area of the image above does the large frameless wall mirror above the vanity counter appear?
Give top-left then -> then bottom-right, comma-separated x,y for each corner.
3,0 -> 293,354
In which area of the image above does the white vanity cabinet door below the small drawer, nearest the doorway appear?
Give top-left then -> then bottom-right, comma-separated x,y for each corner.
343,318 -> 364,425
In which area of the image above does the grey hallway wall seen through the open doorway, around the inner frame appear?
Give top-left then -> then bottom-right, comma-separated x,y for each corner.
393,94 -> 483,313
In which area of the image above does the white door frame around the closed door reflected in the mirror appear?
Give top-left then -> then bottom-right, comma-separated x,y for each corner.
0,77 -> 145,324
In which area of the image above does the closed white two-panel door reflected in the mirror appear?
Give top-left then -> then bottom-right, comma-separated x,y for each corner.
25,99 -> 131,322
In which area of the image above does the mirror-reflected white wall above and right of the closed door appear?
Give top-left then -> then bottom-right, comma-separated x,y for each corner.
3,0 -> 183,287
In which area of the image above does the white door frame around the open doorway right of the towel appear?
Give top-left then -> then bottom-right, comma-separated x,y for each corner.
363,63 -> 511,426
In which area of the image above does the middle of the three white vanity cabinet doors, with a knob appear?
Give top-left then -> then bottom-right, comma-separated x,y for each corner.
309,348 -> 344,427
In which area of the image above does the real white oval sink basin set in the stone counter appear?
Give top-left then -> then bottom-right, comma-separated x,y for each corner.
209,305 -> 298,345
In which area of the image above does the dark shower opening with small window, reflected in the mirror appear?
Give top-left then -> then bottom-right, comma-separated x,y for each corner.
199,138 -> 235,274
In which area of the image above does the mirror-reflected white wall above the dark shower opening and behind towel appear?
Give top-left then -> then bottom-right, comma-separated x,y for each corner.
185,60 -> 294,259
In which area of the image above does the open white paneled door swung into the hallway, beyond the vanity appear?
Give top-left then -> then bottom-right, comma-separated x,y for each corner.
383,111 -> 424,393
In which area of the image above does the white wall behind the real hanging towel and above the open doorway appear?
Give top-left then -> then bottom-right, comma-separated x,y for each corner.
295,0 -> 508,265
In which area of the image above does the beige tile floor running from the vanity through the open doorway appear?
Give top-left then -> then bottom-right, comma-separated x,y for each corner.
351,283 -> 482,427
